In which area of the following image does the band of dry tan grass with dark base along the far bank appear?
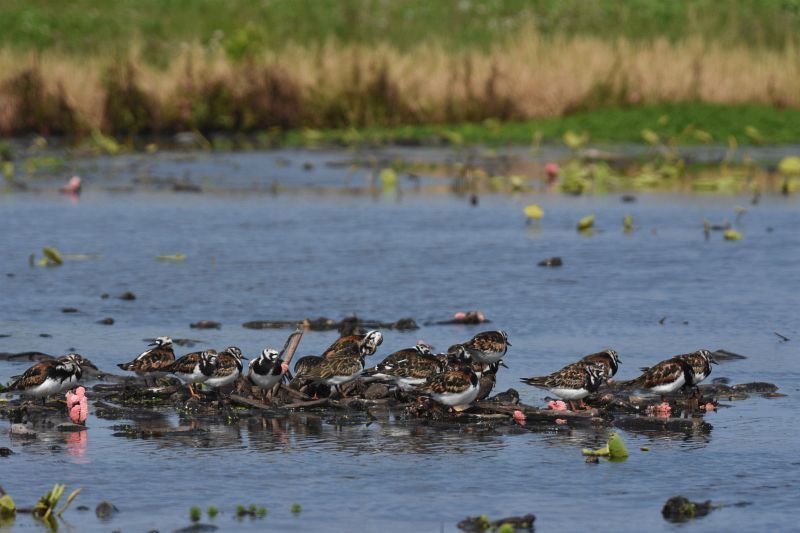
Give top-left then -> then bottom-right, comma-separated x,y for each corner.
0,31 -> 800,135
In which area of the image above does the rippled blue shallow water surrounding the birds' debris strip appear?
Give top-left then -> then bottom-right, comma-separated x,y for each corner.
0,148 -> 800,531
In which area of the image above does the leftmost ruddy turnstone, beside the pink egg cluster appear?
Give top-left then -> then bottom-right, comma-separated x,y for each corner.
5,353 -> 96,402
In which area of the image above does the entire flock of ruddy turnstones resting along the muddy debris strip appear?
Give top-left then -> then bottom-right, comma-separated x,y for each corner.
6,331 -> 716,410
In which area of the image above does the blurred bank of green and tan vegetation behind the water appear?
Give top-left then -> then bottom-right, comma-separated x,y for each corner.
0,0 -> 800,143
